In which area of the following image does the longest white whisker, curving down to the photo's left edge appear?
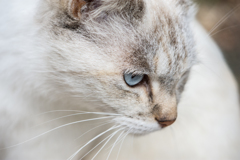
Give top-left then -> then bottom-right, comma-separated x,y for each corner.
0,116 -> 113,151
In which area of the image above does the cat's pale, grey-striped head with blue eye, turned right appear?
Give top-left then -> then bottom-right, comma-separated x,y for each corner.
42,0 -> 195,134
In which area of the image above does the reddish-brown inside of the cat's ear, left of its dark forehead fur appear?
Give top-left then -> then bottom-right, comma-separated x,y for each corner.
62,0 -> 101,20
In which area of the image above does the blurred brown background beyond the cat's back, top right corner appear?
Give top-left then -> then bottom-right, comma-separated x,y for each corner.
195,0 -> 240,90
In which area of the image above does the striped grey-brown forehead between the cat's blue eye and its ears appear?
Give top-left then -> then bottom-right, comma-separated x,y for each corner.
101,1 -> 195,75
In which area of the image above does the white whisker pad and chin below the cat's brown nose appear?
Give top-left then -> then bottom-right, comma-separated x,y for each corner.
113,117 -> 162,135
